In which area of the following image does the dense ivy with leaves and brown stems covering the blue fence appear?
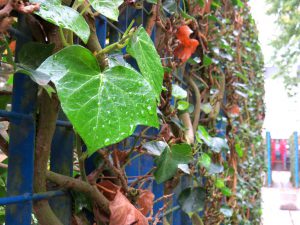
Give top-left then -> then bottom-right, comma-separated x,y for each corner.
2,0 -> 264,225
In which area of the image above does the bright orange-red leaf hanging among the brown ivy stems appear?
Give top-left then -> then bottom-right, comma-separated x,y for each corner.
174,25 -> 199,63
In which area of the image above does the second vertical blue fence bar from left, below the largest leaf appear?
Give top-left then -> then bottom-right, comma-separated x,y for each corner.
49,111 -> 74,225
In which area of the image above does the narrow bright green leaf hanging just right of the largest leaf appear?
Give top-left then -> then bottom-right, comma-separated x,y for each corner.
126,27 -> 164,99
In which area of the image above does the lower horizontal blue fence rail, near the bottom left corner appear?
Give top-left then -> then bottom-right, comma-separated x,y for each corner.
0,191 -> 66,205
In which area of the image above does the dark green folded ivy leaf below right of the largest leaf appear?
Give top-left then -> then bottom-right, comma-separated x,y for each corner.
154,144 -> 193,183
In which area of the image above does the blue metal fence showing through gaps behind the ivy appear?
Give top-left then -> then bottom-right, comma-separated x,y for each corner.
0,4 -> 192,225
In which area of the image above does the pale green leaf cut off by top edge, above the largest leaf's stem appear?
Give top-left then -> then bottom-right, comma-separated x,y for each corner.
89,0 -> 124,21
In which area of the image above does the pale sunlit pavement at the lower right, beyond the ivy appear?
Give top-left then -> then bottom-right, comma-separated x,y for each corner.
262,171 -> 300,225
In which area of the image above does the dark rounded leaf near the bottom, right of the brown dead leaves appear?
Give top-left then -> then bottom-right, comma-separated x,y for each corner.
178,187 -> 206,214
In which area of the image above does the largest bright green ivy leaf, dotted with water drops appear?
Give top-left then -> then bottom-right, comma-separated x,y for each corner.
37,45 -> 158,154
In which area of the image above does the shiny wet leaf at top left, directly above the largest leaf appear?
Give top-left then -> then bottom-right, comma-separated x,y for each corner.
31,0 -> 90,43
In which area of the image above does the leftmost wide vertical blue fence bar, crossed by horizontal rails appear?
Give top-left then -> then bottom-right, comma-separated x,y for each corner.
5,15 -> 37,225
